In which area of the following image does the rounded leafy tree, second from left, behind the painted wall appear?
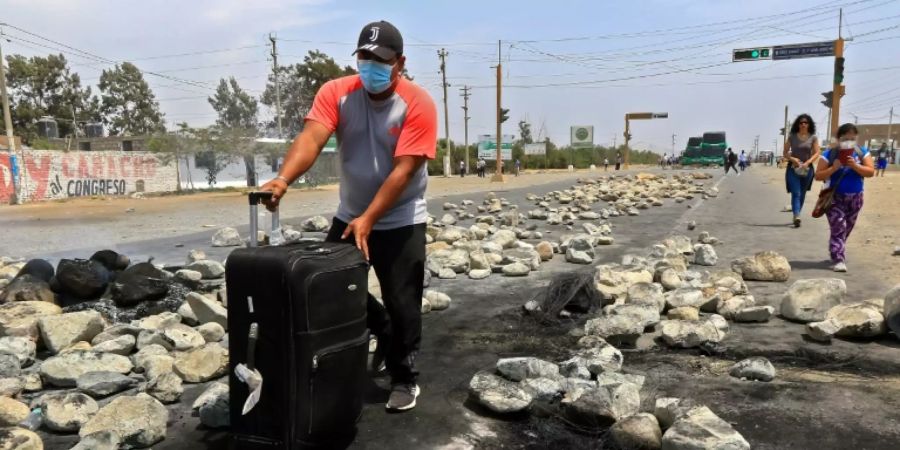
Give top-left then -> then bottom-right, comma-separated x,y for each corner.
99,62 -> 165,135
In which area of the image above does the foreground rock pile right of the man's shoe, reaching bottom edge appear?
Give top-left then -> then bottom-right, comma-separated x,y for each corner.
469,336 -> 750,449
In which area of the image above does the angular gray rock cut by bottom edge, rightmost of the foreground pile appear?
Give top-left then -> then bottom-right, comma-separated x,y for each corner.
662,406 -> 750,450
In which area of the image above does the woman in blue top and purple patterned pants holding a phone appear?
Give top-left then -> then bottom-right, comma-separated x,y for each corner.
816,123 -> 875,272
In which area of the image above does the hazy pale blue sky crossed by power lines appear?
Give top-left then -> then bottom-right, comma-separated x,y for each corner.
0,0 -> 900,152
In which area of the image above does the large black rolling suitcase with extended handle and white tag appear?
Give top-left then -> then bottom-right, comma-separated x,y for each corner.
225,193 -> 369,449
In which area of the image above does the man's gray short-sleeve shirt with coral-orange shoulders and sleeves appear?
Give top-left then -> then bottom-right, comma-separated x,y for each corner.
306,75 -> 437,230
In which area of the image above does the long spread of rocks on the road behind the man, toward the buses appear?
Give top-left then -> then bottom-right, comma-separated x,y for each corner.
426,174 -> 718,280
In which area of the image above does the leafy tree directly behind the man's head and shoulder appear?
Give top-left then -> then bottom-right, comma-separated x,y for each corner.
260,50 -> 356,136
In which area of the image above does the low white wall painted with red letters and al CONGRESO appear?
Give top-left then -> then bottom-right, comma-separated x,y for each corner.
0,150 -> 177,202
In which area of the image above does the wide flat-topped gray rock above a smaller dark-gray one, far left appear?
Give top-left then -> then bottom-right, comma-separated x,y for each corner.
40,350 -> 133,387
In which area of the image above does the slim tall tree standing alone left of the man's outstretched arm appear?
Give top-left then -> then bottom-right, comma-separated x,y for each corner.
209,77 -> 259,186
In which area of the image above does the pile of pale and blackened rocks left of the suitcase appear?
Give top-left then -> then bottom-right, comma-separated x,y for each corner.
0,251 -> 228,449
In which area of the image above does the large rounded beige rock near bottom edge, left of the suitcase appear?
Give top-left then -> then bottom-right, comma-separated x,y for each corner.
78,393 -> 169,448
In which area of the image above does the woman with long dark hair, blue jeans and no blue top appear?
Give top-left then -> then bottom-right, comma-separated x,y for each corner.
784,114 -> 820,228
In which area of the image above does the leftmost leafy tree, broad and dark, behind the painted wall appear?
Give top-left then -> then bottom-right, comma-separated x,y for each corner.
0,54 -> 100,143
